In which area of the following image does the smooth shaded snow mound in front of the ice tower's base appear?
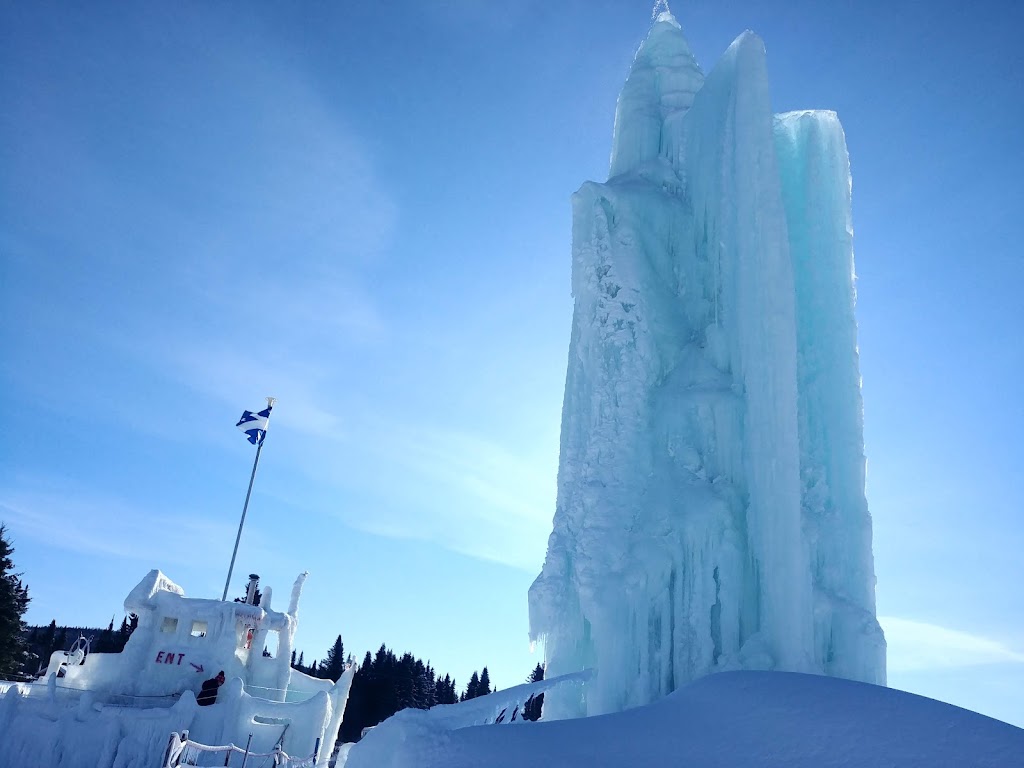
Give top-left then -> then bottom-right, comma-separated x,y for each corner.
346,672 -> 1024,768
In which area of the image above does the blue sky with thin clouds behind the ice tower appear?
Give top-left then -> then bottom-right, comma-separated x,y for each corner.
0,0 -> 1024,725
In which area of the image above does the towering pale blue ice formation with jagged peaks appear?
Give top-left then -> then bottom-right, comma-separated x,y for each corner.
529,11 -> 886,718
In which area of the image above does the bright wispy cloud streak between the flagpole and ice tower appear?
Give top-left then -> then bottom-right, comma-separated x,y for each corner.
258,413 -> 555,571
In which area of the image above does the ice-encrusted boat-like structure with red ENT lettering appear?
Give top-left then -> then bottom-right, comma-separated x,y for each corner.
0,570 -> 355,768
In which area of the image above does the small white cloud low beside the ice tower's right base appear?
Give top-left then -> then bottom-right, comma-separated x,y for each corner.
879,616 -> 1024,672
